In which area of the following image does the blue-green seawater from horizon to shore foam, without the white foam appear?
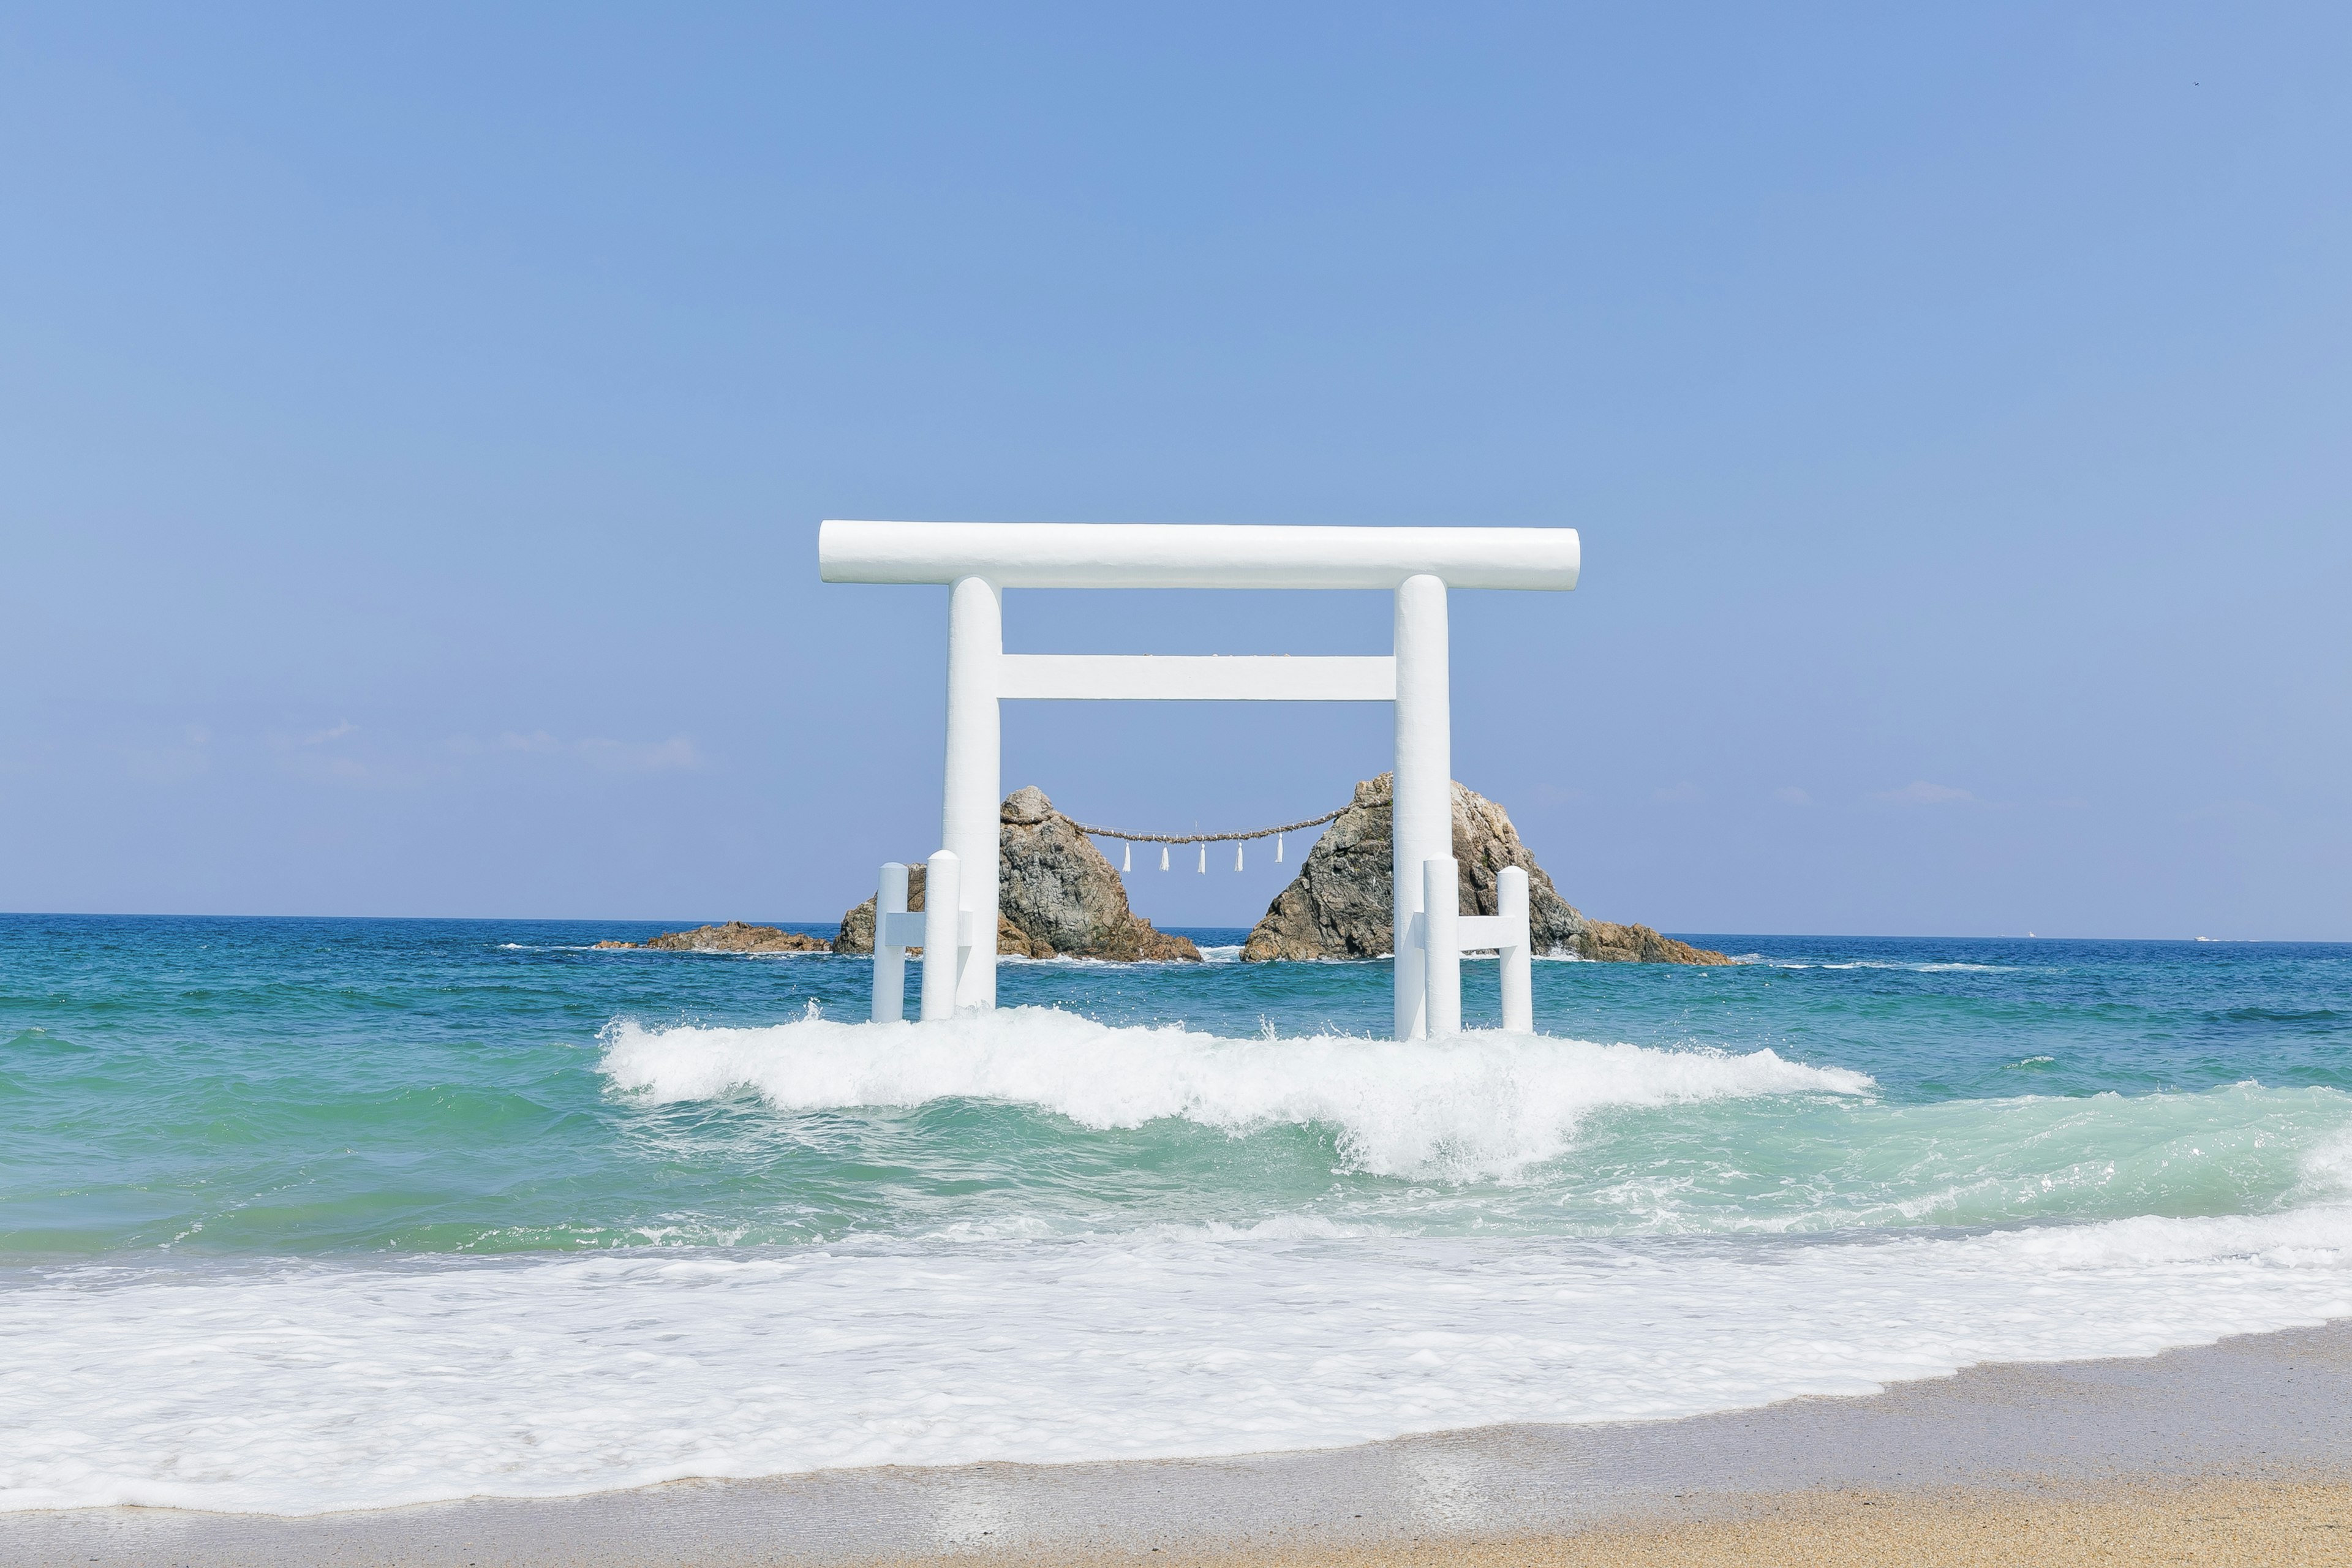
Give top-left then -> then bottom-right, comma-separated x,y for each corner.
0,917 -> 2352,1260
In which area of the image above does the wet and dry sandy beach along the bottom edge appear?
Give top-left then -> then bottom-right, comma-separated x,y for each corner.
0,1319 -> 2352,1568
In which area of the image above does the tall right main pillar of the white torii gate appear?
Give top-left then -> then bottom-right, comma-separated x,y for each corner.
1388,573 -> 1461,1039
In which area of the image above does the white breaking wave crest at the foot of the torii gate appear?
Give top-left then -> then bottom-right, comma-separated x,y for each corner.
602,1009 -> 1874,1178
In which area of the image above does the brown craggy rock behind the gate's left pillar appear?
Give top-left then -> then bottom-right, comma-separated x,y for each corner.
832,785 -> 1199,964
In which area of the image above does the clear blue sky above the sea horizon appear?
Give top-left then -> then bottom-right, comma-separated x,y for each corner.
0,5 -> 2352,938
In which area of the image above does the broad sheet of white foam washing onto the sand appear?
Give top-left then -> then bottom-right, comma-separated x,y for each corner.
0,1208 -> 2352,1512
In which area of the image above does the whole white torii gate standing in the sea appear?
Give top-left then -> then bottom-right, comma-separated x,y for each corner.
816,522 -> 1580,1039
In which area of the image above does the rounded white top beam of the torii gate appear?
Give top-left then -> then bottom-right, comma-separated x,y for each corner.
816,522 -> 1580,590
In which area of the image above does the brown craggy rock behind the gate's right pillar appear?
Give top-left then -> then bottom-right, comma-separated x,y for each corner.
1242,774 -> 1731,964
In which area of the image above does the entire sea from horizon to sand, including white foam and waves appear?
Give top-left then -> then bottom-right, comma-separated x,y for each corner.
0,914 -> 2352,1514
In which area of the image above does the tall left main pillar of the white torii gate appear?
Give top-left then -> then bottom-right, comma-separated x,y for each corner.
941,576 -> 1005,1018
